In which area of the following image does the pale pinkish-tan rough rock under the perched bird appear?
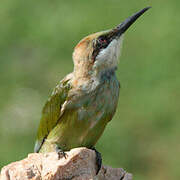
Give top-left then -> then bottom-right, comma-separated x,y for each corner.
0,148 -> 132,180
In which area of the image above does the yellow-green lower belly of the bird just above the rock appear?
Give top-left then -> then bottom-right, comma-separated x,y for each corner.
48,111 -> 109,150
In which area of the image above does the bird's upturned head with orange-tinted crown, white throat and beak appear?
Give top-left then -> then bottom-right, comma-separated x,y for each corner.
73,7 -> 150,77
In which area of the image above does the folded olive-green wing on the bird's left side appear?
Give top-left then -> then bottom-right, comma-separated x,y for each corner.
34,75 -> 71,152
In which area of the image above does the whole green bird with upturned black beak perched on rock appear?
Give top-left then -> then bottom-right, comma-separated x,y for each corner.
34,7 -> 150,173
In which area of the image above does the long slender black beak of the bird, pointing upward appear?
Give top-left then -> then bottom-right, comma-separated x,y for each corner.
113,7 -> 151,37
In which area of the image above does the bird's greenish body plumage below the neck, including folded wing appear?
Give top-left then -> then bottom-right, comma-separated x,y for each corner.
35,73 -> 119,152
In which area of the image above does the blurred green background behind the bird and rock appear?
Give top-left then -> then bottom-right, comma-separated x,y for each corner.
0,0 -> 180,180
